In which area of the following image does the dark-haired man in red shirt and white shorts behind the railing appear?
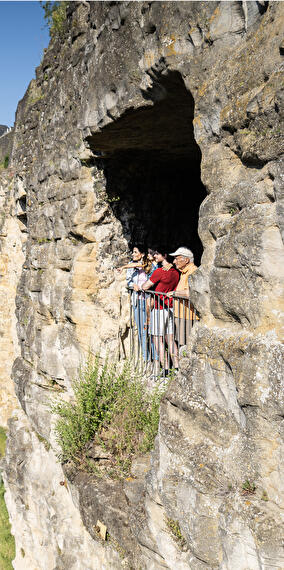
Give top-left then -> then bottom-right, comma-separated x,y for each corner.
142,248 -> 179,376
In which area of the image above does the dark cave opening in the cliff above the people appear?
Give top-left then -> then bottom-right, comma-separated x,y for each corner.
88,72 -> 206,265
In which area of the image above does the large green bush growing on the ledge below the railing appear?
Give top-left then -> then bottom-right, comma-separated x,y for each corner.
52,355 -> 164,475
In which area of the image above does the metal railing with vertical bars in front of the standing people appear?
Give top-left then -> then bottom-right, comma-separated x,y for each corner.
127,287 -> 198,379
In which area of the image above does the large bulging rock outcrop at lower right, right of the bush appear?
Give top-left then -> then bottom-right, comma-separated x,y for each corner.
143,327 -> 284,569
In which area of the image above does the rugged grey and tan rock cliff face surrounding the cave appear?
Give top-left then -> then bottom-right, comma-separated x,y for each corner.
1,1 -> 284,570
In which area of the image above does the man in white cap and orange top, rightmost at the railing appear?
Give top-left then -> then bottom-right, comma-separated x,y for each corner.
170,247 -> 197,346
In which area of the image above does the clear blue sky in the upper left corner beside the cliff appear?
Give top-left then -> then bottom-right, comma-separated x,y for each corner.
0,0 -> 49,127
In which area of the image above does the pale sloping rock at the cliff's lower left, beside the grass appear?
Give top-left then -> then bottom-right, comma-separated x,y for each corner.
4,410 -> 121,570
